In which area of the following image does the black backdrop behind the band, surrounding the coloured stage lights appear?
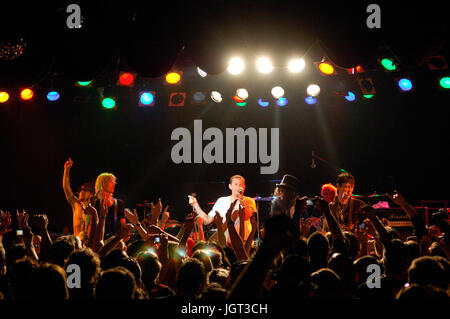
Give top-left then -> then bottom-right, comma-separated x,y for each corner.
0,1 -> 450,231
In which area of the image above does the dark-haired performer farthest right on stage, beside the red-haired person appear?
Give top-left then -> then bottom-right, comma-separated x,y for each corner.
325,173 -> 366,232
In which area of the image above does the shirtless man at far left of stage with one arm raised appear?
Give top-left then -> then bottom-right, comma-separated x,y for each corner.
63,158 -> 94,241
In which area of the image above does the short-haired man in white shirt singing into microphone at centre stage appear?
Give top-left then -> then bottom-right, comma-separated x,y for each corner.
192,175 -> 256,241
